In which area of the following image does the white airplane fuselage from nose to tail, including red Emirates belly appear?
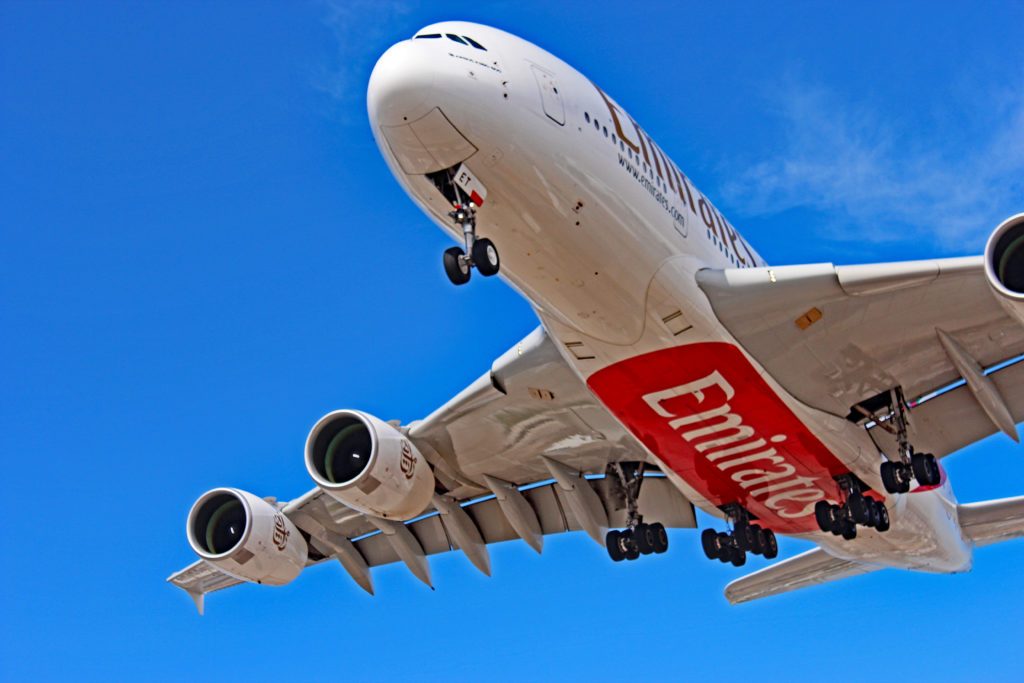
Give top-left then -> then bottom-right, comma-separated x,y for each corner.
368,22 -> 972,571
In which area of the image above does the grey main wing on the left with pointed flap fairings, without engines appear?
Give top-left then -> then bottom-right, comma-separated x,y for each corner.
168,328 -> 696,612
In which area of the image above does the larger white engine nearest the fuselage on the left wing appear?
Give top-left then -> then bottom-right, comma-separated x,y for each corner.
306,411 -> 434,521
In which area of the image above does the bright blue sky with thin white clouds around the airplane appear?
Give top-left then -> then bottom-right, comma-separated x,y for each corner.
0,1 -> 1024,680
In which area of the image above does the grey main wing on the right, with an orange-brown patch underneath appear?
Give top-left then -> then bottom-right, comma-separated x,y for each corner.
697,257 -> 1024,456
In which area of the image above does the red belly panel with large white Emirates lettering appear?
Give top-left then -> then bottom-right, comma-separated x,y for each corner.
587,342 -> 849,532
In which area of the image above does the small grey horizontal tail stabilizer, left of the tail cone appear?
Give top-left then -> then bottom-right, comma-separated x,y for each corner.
725,548 -> 880,605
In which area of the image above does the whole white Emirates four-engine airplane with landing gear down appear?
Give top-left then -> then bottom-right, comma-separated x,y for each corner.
168,22 -> 1024,613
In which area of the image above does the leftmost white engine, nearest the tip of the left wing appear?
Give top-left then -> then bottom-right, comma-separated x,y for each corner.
187,488 -> 308,586
